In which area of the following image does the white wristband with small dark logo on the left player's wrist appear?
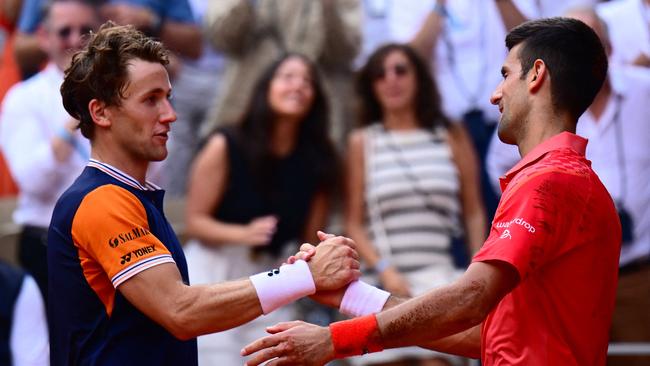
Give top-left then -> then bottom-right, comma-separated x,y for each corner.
250,260 -> 316,314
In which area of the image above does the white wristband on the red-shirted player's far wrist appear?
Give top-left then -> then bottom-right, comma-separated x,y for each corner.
339,281 -> 390,317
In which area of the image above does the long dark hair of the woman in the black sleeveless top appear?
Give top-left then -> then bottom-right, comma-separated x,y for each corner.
223,53 -> 339,191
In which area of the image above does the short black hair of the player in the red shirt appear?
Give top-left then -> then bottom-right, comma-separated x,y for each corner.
506,17 -> 607,120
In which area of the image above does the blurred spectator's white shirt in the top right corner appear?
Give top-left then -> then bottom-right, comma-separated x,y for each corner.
597,0 -> 650,73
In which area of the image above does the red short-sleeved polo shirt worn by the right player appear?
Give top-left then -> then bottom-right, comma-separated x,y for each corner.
473,132 -> 621,366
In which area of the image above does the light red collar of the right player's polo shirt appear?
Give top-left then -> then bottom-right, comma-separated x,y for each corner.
499,131 -> 587,192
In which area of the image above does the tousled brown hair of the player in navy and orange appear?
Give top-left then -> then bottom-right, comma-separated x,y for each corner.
61,21 -> 169,140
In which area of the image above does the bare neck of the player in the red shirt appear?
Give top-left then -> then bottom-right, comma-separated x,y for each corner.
517,113 -> 576,157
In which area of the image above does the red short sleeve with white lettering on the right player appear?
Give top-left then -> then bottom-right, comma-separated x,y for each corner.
472,172 -> 584,280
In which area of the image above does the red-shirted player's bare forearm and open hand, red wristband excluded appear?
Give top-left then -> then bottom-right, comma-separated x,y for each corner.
242,261 -> 519,365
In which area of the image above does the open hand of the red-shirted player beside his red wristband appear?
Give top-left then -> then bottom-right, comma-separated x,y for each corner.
241,320 -> 334,366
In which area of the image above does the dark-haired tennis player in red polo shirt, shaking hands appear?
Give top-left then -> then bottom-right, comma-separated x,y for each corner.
242,18 -> 621,366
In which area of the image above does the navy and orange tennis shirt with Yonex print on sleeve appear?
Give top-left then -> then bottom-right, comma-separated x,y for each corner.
47,160 -> 198,365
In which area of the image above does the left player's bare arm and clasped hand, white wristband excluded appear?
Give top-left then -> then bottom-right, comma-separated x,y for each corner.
118,237 -> 360,339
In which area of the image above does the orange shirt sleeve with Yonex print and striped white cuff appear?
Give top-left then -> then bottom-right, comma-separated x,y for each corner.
72,185 -> 174,288
